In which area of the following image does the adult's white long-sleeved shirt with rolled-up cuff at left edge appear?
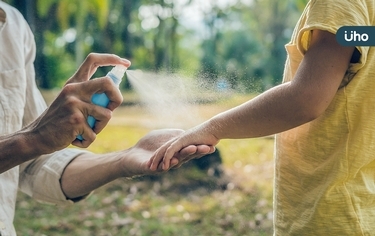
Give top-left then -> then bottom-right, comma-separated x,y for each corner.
0,1 -> 87,236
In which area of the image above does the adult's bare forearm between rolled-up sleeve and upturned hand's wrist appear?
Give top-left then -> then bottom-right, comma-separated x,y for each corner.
61,150 -> 123,199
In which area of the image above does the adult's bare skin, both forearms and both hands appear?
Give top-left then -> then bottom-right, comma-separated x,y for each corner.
0,53 -> 214,199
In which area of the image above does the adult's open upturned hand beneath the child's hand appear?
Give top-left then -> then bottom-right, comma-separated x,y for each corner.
121,129 -> 215,177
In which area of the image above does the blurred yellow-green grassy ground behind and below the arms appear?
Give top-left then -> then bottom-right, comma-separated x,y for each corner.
15,94 -> 273,236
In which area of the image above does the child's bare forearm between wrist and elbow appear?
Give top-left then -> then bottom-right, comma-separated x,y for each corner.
205,83 -> 320,139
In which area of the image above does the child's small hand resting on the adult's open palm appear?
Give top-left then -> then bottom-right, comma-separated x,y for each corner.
147,122 -> 219,171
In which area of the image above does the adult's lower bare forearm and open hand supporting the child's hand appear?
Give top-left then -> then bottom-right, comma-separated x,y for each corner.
61,129 -> 214,199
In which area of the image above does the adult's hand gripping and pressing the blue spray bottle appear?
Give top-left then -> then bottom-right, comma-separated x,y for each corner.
26,53 -> 130,154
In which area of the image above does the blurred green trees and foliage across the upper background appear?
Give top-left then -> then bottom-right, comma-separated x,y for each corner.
7,0 -> 307,92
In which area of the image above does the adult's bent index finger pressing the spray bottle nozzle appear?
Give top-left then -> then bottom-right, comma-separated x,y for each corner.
70,53 -> 131,82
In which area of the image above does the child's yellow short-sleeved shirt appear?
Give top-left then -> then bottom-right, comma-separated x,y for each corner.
274,0 -> 375,236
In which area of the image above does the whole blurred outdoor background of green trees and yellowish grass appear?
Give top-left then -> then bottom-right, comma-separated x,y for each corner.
5,0 -> 307,236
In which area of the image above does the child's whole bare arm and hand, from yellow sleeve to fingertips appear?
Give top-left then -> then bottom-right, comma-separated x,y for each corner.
148,30 -> 357,170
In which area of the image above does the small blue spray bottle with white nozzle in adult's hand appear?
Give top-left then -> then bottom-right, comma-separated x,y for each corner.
77,65 -> 128,141
